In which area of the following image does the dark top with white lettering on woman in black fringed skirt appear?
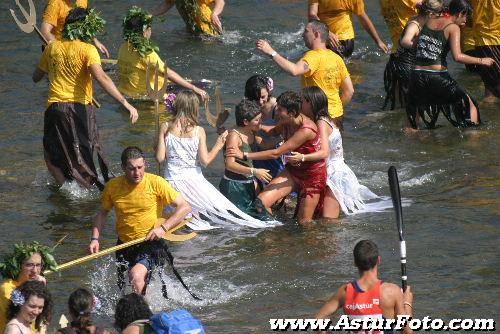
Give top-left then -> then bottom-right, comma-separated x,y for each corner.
415,23 -> 453,67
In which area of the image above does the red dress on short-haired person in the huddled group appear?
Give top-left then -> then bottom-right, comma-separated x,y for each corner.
286,124 -> 326,200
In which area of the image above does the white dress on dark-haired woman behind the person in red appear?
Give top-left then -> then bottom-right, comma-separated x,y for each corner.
322,118 -> 380,215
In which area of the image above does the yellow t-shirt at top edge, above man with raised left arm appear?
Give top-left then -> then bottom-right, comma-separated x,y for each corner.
309,0 -> 365,41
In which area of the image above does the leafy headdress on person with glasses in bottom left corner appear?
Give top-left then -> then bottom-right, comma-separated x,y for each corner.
0,241 -> 57,280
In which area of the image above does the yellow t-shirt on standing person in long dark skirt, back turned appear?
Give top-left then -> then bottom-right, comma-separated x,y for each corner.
38,40 -> 101,104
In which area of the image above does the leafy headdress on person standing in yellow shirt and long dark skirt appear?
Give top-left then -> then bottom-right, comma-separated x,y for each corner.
62,7 -> 106,43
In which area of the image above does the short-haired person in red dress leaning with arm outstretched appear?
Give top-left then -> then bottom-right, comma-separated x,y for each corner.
227,91 -> 326,224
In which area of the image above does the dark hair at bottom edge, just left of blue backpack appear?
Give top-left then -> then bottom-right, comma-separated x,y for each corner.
115,293 -> 153,332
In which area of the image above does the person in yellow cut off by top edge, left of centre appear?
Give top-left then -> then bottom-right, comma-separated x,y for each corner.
152,0 -> 225,36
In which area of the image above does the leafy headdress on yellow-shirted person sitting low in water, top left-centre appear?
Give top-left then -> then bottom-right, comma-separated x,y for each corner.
122,6 -> 159,57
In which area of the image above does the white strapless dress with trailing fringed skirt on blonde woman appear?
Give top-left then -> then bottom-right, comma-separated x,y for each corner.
164,127 -> 277,230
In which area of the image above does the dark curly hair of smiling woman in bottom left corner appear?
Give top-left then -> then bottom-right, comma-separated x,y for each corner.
7,281 -> 52,330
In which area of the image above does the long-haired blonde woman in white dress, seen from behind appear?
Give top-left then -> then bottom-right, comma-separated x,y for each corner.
156,91 -> 273,230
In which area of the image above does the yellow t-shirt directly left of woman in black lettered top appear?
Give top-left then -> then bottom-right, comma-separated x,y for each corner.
380,0 -> 418,52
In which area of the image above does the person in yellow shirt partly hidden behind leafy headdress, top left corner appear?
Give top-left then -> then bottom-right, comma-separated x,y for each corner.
40,0 -> 109,58
